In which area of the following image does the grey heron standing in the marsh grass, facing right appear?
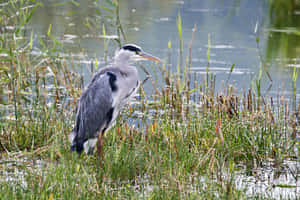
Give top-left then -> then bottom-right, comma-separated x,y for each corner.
69,44 -> 160,155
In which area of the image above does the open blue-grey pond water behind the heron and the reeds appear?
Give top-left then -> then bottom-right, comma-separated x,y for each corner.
28,0 -> 300,104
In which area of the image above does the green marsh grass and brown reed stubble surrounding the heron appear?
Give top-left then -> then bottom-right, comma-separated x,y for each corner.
0,1 -> 300,200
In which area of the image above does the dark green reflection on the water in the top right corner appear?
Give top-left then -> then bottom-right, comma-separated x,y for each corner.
266,1 -> 300,67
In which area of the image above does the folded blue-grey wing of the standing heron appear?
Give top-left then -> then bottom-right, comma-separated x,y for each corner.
75,73 -> 113,143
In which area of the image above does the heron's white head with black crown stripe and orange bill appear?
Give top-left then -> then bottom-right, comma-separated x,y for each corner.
115,44 -> 161,63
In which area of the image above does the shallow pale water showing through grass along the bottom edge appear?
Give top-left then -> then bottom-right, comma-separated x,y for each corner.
0,158 -> 300,199
